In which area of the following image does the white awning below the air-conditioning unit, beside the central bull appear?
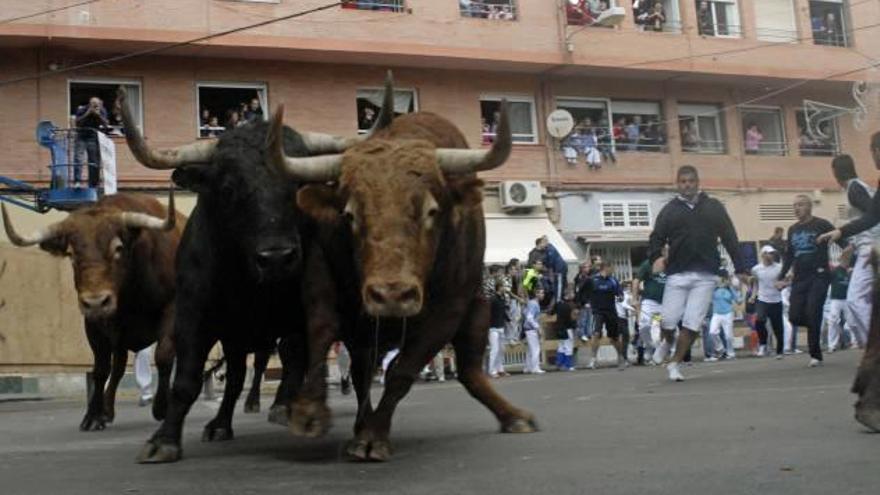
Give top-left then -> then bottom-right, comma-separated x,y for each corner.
485,213 -> 578,264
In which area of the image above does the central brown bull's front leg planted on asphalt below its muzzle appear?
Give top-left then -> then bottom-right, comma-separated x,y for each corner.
348,332 -> 450,461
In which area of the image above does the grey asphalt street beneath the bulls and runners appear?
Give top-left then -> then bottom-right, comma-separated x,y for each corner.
0,351 -> 880,495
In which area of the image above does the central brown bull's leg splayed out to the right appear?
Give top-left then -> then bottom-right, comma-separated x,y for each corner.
452,300 -> 538,433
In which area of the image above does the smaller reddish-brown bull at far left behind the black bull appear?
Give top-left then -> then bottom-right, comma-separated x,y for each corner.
3,193 -> 180,431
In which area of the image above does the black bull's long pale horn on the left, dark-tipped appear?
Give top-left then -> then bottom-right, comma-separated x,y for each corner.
116,86 -> 217,170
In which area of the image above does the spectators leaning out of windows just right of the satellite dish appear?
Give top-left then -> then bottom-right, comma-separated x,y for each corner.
561,115 -> 666,170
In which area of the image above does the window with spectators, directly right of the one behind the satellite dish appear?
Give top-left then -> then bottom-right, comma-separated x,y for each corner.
611,100 -> 666,152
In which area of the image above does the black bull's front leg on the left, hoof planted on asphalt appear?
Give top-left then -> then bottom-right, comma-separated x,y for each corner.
137,322 -> 215,464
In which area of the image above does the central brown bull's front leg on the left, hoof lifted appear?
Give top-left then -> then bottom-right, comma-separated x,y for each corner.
288,248 -> 339,438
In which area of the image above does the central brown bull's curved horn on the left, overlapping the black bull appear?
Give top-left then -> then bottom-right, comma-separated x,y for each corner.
266,105 -> 342,182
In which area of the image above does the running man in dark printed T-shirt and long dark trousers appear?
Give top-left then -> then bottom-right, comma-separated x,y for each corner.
778,194 -> 834,368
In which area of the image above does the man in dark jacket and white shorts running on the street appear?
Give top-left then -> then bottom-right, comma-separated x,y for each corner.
649,165 -> 748,382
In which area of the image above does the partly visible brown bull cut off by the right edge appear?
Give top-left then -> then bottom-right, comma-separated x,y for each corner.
852,250 -> 880,433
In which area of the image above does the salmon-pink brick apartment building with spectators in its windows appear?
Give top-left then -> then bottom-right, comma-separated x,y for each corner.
0,0 -> 880,368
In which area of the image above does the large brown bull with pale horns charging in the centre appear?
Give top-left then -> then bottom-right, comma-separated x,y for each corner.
274,72 -> 536,460
